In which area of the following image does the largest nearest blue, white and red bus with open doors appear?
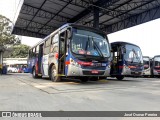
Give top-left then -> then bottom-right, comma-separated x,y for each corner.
28,24 -> 110,82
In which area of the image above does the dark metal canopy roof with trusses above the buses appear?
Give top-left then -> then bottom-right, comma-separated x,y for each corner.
12,0 -> 160,38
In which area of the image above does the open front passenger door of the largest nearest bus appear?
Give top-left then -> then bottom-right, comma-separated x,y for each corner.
58,31 -> 66,75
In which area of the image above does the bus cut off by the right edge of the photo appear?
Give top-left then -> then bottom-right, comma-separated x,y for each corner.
152,55 -> 160,77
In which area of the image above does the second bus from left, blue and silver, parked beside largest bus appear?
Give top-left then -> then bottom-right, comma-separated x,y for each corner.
110,42 -> 143,80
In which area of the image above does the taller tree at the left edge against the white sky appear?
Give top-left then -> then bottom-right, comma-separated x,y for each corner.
0,15 -> 20,50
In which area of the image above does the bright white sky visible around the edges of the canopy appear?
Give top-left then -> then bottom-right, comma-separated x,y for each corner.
0,0 -> 160,57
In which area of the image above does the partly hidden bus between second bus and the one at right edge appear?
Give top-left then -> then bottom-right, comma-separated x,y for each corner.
143,56 -> 152,77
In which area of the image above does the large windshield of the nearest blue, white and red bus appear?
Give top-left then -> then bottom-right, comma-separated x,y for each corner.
71,28 -> 110,57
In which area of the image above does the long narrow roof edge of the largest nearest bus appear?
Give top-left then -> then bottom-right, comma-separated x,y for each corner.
30,23 -> 106,49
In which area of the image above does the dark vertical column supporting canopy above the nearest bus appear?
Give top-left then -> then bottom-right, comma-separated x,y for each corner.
93,7 -> 99,29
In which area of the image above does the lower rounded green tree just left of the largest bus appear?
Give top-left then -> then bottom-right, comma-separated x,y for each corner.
5,44 -> 30,58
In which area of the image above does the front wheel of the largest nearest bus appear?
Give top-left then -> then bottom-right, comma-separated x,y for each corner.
50,65 -> 61,82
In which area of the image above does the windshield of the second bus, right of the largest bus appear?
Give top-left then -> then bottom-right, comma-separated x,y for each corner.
124,44 -> 143,63
